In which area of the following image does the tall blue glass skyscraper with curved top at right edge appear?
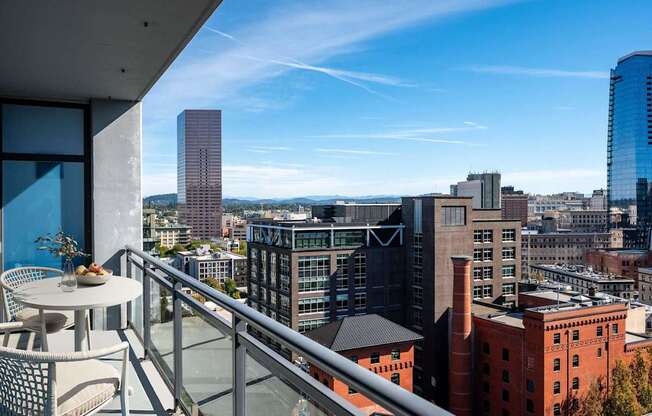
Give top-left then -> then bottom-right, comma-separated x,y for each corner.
607,51 -> 652,247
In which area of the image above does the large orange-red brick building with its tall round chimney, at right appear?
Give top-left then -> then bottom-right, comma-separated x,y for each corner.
449,255 -> 652,416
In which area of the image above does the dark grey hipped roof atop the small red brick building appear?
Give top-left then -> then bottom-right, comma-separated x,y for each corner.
304,314 -> 423,351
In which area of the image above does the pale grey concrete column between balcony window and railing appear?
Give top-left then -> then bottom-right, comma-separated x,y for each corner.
91,100 -> 143,329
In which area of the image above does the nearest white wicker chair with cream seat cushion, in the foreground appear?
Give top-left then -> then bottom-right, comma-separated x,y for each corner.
0,322 -> 129,416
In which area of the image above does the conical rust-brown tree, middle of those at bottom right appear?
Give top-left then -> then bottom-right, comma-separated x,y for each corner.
604,361 -> 641,416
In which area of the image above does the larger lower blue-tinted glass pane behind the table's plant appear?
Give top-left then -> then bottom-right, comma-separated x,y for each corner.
2,161 -> 84,270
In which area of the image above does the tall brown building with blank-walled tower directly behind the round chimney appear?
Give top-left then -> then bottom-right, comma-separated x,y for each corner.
402,195 -> 521,406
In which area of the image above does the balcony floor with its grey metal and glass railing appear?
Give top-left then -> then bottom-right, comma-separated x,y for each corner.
10,247 -> 449,416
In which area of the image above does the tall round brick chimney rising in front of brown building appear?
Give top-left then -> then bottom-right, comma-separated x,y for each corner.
448,256 -> 473,416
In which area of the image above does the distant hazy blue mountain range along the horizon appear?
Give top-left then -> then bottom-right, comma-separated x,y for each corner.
143,194 -> 401,207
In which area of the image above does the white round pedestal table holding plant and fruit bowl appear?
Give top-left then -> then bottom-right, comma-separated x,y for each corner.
14,276 -> 143,351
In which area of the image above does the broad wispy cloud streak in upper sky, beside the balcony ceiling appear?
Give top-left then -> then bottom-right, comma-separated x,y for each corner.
146,0 -> 513,118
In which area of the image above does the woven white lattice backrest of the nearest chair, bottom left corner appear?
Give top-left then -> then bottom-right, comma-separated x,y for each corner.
0,347 -> 57,416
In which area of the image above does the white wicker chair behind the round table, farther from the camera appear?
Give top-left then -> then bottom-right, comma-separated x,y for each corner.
0,267 -> 91,351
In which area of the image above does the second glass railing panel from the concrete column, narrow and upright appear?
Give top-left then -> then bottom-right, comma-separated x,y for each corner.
148,277 -> 174,382
